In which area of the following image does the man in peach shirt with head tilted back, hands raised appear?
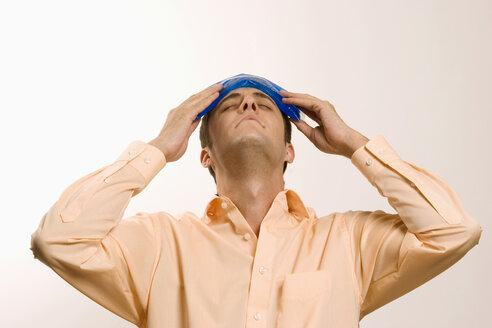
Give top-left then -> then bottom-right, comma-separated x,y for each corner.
31,76 -> 482,328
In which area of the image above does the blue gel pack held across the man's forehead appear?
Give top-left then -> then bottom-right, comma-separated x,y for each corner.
195,73 -> 301,121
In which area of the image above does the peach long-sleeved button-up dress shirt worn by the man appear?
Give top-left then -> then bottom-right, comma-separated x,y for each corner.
31,135 -> 483,328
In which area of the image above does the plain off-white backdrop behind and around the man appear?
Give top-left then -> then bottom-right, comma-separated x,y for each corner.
0,0 -> 492,328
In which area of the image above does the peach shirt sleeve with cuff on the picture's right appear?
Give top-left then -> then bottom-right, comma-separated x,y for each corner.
344,135 -> 483,319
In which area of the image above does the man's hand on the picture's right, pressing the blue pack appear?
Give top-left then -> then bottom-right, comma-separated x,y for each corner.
280,90 -> 369,158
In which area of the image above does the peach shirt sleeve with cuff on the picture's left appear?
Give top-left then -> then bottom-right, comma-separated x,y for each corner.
31,140 -> 166,326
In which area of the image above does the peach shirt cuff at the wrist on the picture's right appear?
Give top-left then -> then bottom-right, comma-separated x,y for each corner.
350,135 -> 401,186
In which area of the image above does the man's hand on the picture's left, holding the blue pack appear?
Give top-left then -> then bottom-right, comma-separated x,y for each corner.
148,84 -> 223,162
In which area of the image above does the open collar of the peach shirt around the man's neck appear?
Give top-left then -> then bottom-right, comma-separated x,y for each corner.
203,189 -> 310,222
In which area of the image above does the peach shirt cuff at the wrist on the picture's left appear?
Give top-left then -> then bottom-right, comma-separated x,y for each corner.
116,140 -> 167,184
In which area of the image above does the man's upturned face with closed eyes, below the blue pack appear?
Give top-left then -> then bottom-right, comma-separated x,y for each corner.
203,88 -> 291,172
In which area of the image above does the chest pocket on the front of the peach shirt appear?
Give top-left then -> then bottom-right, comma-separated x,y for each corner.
275,270 -> 331,328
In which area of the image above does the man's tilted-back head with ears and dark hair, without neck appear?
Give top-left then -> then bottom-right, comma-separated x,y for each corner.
200,87 -> 294,183
